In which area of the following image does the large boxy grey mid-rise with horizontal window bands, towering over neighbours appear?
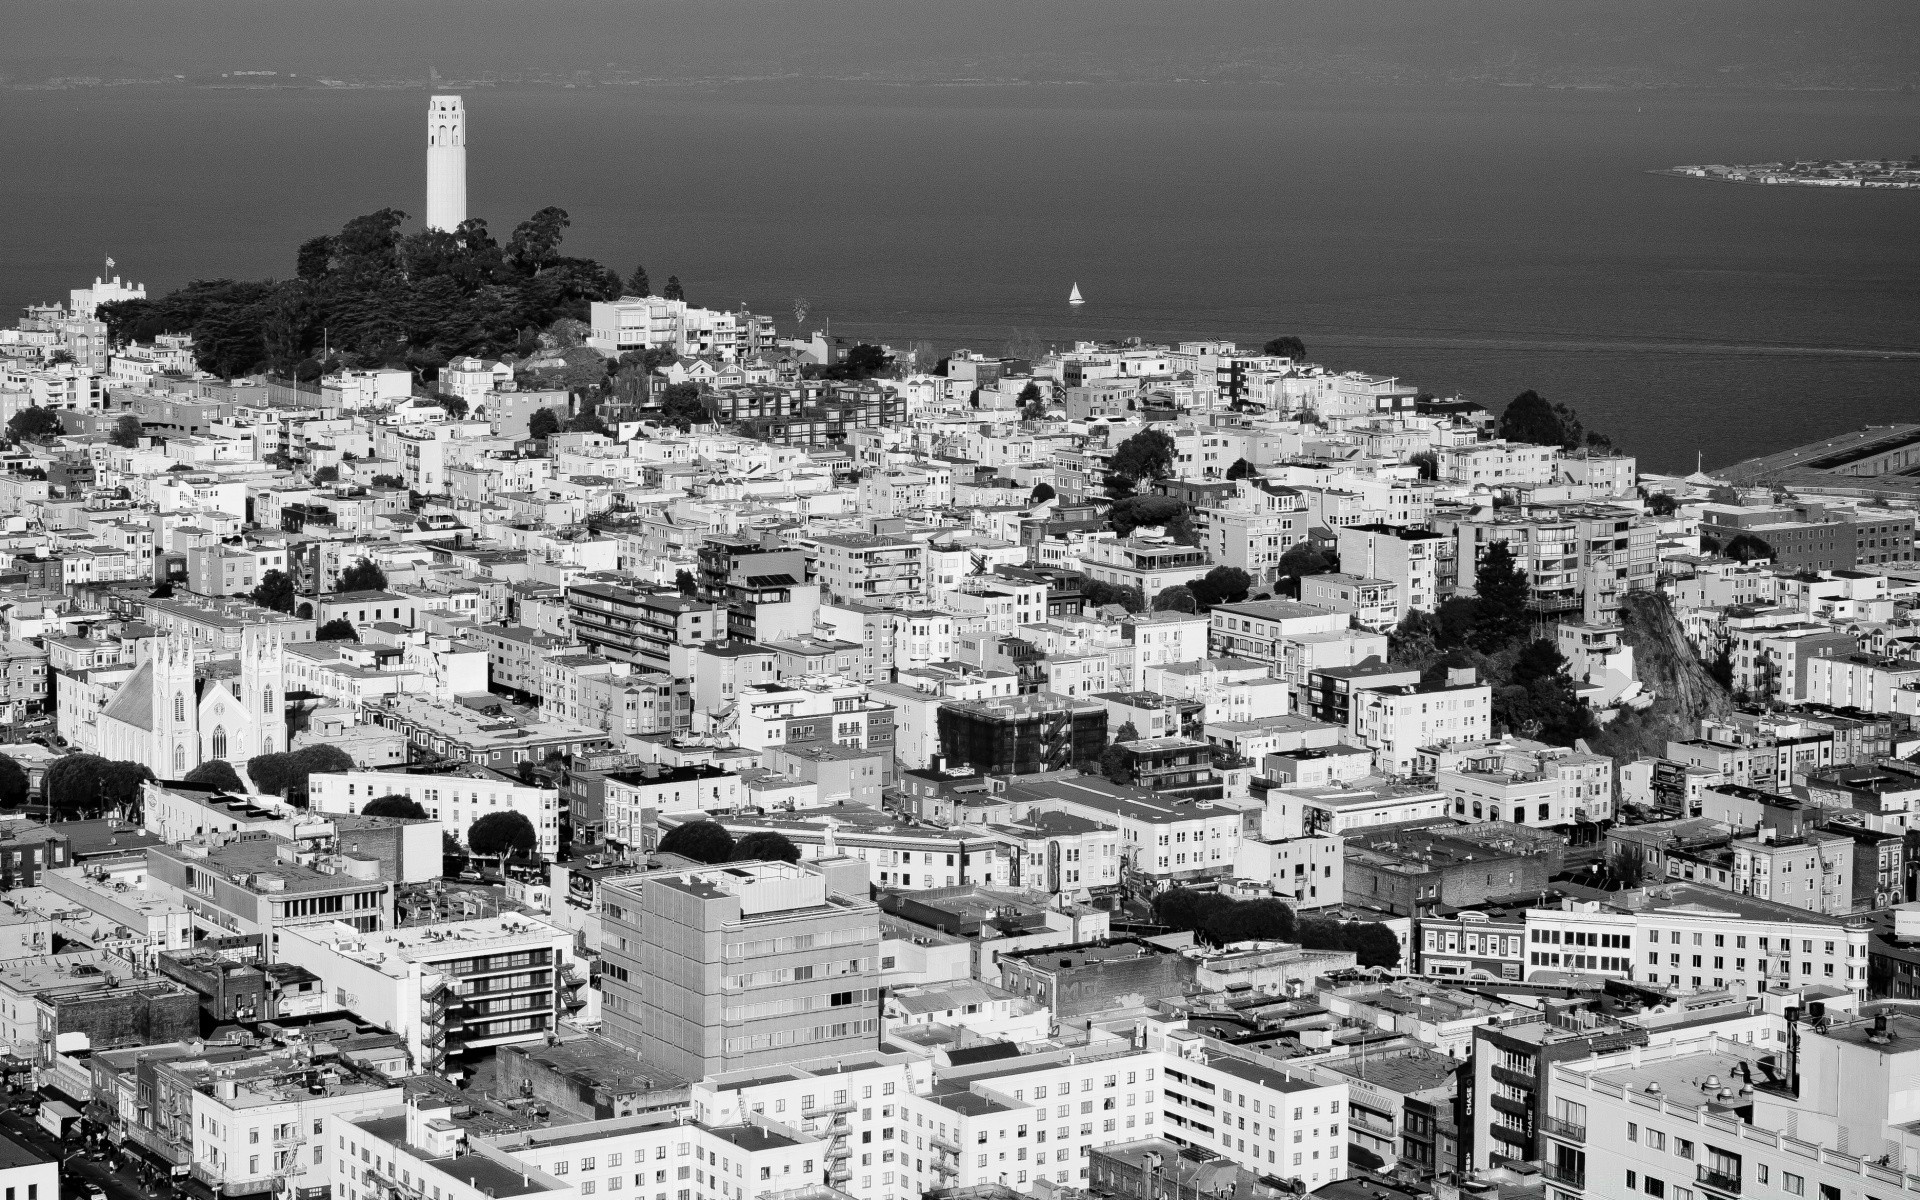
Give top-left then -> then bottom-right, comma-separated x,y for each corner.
601,858 -> 879,1079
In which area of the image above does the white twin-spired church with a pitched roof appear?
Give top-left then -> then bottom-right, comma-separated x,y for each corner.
96,628 -> 288,780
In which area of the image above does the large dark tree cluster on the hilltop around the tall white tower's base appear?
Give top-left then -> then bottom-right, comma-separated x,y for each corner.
100,207 -> 624,378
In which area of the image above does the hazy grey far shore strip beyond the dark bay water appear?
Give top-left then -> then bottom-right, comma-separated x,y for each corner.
0,0 -> 1920,88
